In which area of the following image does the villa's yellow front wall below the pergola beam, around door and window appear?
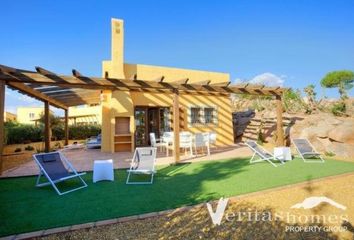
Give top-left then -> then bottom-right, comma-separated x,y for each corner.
102,91 -> 233,152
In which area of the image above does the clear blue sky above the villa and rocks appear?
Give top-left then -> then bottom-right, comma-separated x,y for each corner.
0,0 -> 354,114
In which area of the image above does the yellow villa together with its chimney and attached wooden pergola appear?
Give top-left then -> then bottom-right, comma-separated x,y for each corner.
0,19 -> 286,172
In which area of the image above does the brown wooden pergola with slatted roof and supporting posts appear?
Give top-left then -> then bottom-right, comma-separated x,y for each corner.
0,65 -> 286,173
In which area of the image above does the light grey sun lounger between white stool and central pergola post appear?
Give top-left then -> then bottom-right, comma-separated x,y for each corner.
126,147 -> 157,184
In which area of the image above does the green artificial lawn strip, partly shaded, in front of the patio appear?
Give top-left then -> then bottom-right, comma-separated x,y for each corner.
0,159 -> 354,236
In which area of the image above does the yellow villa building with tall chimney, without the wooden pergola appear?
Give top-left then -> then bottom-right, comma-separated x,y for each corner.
102,19 -> 233,152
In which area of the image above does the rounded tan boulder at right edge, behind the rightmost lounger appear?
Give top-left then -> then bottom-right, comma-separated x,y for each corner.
328,122 -> 354,145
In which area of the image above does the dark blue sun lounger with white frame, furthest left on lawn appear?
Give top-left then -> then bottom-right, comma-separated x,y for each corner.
33,152 -> 87,195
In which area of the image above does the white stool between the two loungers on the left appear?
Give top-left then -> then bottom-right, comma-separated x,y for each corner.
93,159 -> 114,183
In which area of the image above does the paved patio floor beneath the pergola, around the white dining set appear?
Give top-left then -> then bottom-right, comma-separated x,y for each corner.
0,144 -> 252,178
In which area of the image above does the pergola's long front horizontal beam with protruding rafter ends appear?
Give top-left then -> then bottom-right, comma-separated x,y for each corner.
0,65 -> 284,95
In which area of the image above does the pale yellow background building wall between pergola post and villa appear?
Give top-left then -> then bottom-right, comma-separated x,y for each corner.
69,105 -> 102,124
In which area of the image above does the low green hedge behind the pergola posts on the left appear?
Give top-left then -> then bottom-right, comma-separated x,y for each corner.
4,124 -> 101,145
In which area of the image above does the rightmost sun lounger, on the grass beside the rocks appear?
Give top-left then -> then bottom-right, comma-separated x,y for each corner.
292,138 -> 324,163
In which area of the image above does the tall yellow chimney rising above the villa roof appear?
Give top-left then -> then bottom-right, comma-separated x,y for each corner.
109,18 -> 125,78
